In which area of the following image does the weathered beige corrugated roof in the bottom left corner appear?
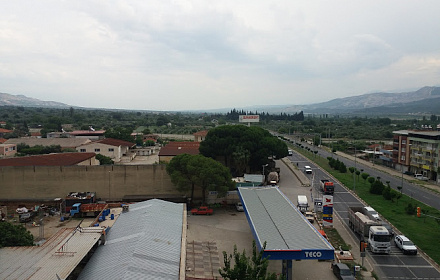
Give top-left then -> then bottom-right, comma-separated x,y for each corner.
0,228 -> 102,280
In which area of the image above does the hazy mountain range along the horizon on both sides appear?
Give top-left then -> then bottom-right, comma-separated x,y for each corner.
0,86 -> 440,115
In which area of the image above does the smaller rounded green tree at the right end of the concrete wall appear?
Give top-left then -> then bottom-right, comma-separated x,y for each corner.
166,154 -> 234,202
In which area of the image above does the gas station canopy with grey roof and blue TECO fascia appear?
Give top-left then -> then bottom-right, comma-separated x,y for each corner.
238,187 -> 334,260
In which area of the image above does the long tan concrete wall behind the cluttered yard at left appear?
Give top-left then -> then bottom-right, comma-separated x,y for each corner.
0,164 -> 193,201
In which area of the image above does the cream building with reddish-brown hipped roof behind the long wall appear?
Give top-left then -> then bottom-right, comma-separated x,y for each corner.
76,138 -> 136,162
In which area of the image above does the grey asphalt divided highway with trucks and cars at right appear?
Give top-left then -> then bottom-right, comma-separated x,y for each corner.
289,147 -> 440,280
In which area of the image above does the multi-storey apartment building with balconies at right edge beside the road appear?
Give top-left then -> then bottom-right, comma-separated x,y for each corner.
393,130 -> 440,180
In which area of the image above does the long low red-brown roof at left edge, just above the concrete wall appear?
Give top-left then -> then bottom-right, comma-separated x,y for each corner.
0,153 -> 96,166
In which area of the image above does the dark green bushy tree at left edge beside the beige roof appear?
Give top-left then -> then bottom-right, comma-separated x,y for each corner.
0,222 -> 34,248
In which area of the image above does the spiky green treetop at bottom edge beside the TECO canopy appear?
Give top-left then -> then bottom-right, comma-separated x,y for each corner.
219,240 -> 284,280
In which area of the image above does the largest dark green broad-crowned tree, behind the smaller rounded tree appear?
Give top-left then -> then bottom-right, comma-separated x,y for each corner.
199,125 -> 288,174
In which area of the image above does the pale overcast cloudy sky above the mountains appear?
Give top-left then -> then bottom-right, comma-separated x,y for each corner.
0,0 -> 440,111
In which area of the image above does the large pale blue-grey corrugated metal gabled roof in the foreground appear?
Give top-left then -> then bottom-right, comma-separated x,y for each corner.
78,199 -> 184,280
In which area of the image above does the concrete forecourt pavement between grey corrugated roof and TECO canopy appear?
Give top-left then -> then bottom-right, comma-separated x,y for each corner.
187,206 -> 336,280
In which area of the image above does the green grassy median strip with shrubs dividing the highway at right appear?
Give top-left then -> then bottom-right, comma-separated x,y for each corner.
293,147 -> 440,264
